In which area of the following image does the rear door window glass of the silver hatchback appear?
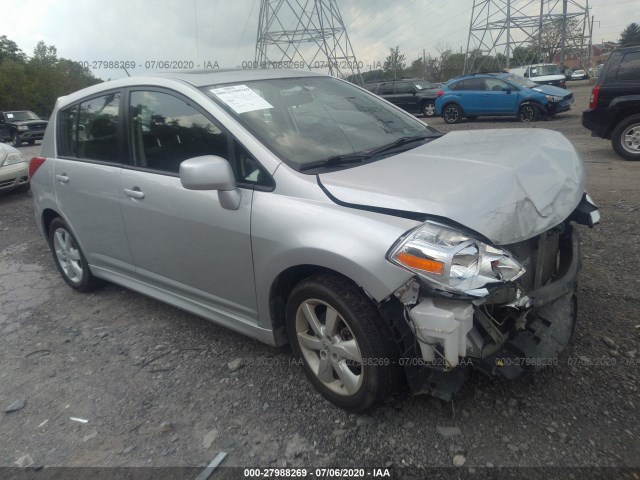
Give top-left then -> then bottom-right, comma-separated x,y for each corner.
58,93 -> 120,162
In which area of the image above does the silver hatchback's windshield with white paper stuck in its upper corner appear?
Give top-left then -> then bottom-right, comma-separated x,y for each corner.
203,77 -> 441,170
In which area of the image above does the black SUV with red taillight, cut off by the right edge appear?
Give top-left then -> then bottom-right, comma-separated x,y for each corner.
582,45 -> 640,160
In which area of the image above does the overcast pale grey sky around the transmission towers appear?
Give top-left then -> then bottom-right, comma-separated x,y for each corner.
0,0 -> 640,79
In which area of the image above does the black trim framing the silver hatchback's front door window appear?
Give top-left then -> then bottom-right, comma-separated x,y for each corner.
122,85 -> 276,192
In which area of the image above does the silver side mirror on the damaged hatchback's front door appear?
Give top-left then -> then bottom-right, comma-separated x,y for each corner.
180,155 -> 242,210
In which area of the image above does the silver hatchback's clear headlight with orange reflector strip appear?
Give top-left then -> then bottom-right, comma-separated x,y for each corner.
387,222 -> 525,296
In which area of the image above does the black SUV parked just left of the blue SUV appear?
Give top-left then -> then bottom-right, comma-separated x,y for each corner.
364,78 -> 438,117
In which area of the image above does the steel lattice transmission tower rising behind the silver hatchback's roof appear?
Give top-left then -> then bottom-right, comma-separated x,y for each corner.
255,0 -> 362,84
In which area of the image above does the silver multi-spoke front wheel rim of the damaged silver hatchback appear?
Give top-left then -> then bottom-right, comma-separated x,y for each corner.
296,299 -> 364,396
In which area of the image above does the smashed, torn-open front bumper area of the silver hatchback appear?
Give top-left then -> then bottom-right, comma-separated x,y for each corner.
381,195 -> 599,400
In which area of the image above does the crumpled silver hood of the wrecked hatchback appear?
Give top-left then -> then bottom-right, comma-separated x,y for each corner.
319,128 -> 585,245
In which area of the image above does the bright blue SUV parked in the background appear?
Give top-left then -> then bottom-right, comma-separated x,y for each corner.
436,73 -> 573,123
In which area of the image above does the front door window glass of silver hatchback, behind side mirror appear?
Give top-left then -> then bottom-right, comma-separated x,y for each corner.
129,91 -> 229,173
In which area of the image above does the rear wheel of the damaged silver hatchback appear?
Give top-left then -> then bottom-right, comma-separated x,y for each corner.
49,217 -> 103,292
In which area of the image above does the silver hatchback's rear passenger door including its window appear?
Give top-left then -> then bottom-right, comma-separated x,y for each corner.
53,91 -> 133,273
